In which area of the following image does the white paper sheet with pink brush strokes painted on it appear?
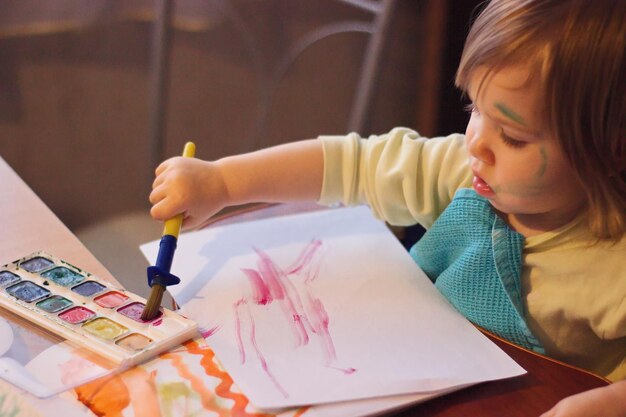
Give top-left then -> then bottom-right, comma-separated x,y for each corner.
141,207 -> 524,409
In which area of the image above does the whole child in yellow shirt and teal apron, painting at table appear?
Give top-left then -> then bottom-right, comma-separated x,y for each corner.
150,0 -> 626,417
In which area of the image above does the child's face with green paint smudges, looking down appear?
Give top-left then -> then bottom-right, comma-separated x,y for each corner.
466,66 -> 584,230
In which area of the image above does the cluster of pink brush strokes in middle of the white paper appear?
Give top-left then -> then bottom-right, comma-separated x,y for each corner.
233,239 -> 356,397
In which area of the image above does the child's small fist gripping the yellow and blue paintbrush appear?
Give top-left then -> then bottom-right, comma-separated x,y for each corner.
150,157 -> 228,229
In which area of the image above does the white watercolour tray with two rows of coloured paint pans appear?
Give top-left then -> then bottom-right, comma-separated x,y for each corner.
0,252 -> 198,367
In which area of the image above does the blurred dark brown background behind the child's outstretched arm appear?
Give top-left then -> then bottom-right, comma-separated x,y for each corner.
0,0 -> 479,289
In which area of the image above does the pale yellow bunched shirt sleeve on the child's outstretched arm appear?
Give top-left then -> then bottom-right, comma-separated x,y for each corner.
319,128 -> 471,227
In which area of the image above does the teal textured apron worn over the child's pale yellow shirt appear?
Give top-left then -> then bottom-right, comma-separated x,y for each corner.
410,189 -> 544,353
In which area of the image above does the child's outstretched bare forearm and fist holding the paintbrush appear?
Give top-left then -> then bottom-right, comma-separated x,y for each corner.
150,139 -> 324,229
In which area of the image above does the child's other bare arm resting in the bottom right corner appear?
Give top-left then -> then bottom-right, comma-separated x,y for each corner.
541,380 -> 626,417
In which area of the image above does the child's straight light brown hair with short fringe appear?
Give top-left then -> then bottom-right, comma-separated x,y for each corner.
456,0 -> 626,241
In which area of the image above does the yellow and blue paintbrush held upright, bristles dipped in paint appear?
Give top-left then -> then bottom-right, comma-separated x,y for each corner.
141,142 -> 196,320
